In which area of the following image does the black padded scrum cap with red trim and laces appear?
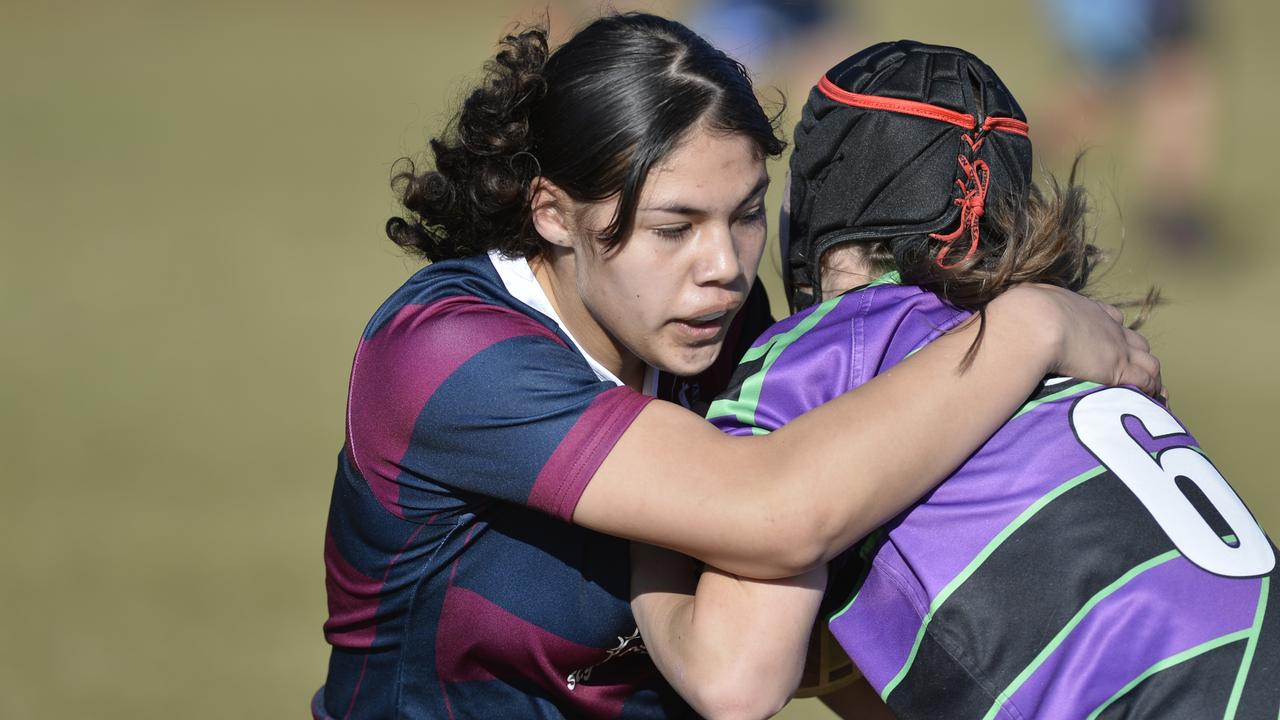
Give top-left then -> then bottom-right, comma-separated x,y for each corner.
782,40 -> 1032,309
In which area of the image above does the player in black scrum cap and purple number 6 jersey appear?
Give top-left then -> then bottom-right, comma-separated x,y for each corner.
634,41 -> 1280,720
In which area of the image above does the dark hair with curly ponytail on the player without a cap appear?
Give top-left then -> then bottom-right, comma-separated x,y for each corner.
387,13 -> 785,261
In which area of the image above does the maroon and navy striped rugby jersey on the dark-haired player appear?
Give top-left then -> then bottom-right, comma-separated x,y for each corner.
312,255 -> 686,719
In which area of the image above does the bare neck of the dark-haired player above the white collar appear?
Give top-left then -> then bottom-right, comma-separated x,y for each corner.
529,249 -> 648,392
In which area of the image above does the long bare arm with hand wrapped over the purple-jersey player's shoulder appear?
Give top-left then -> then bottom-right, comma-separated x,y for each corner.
573,287 -> 1158,579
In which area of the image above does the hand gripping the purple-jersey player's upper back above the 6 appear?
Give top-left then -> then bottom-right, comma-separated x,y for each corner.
992,284 -> 1164,397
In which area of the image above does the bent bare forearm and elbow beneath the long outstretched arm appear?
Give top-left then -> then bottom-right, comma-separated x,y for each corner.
632,544 -> 826,717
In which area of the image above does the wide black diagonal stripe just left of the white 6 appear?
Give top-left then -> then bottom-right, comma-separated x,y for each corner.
887,471 -> 1174,719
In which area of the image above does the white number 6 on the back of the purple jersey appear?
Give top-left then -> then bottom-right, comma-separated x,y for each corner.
1071,387 -> 1276,578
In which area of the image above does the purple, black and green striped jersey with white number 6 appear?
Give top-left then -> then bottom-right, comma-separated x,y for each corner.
708,279 -> 1280,720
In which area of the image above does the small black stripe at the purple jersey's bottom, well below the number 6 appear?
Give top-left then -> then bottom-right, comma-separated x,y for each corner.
1098,639 -> 1244,720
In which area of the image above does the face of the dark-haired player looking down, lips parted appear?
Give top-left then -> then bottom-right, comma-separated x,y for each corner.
542,129 -> 769,384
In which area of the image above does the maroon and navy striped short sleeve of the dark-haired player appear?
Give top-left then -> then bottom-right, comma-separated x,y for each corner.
347,296 -> 650,521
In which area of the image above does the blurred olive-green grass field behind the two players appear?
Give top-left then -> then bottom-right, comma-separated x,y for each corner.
0,0 -> 1280,719
